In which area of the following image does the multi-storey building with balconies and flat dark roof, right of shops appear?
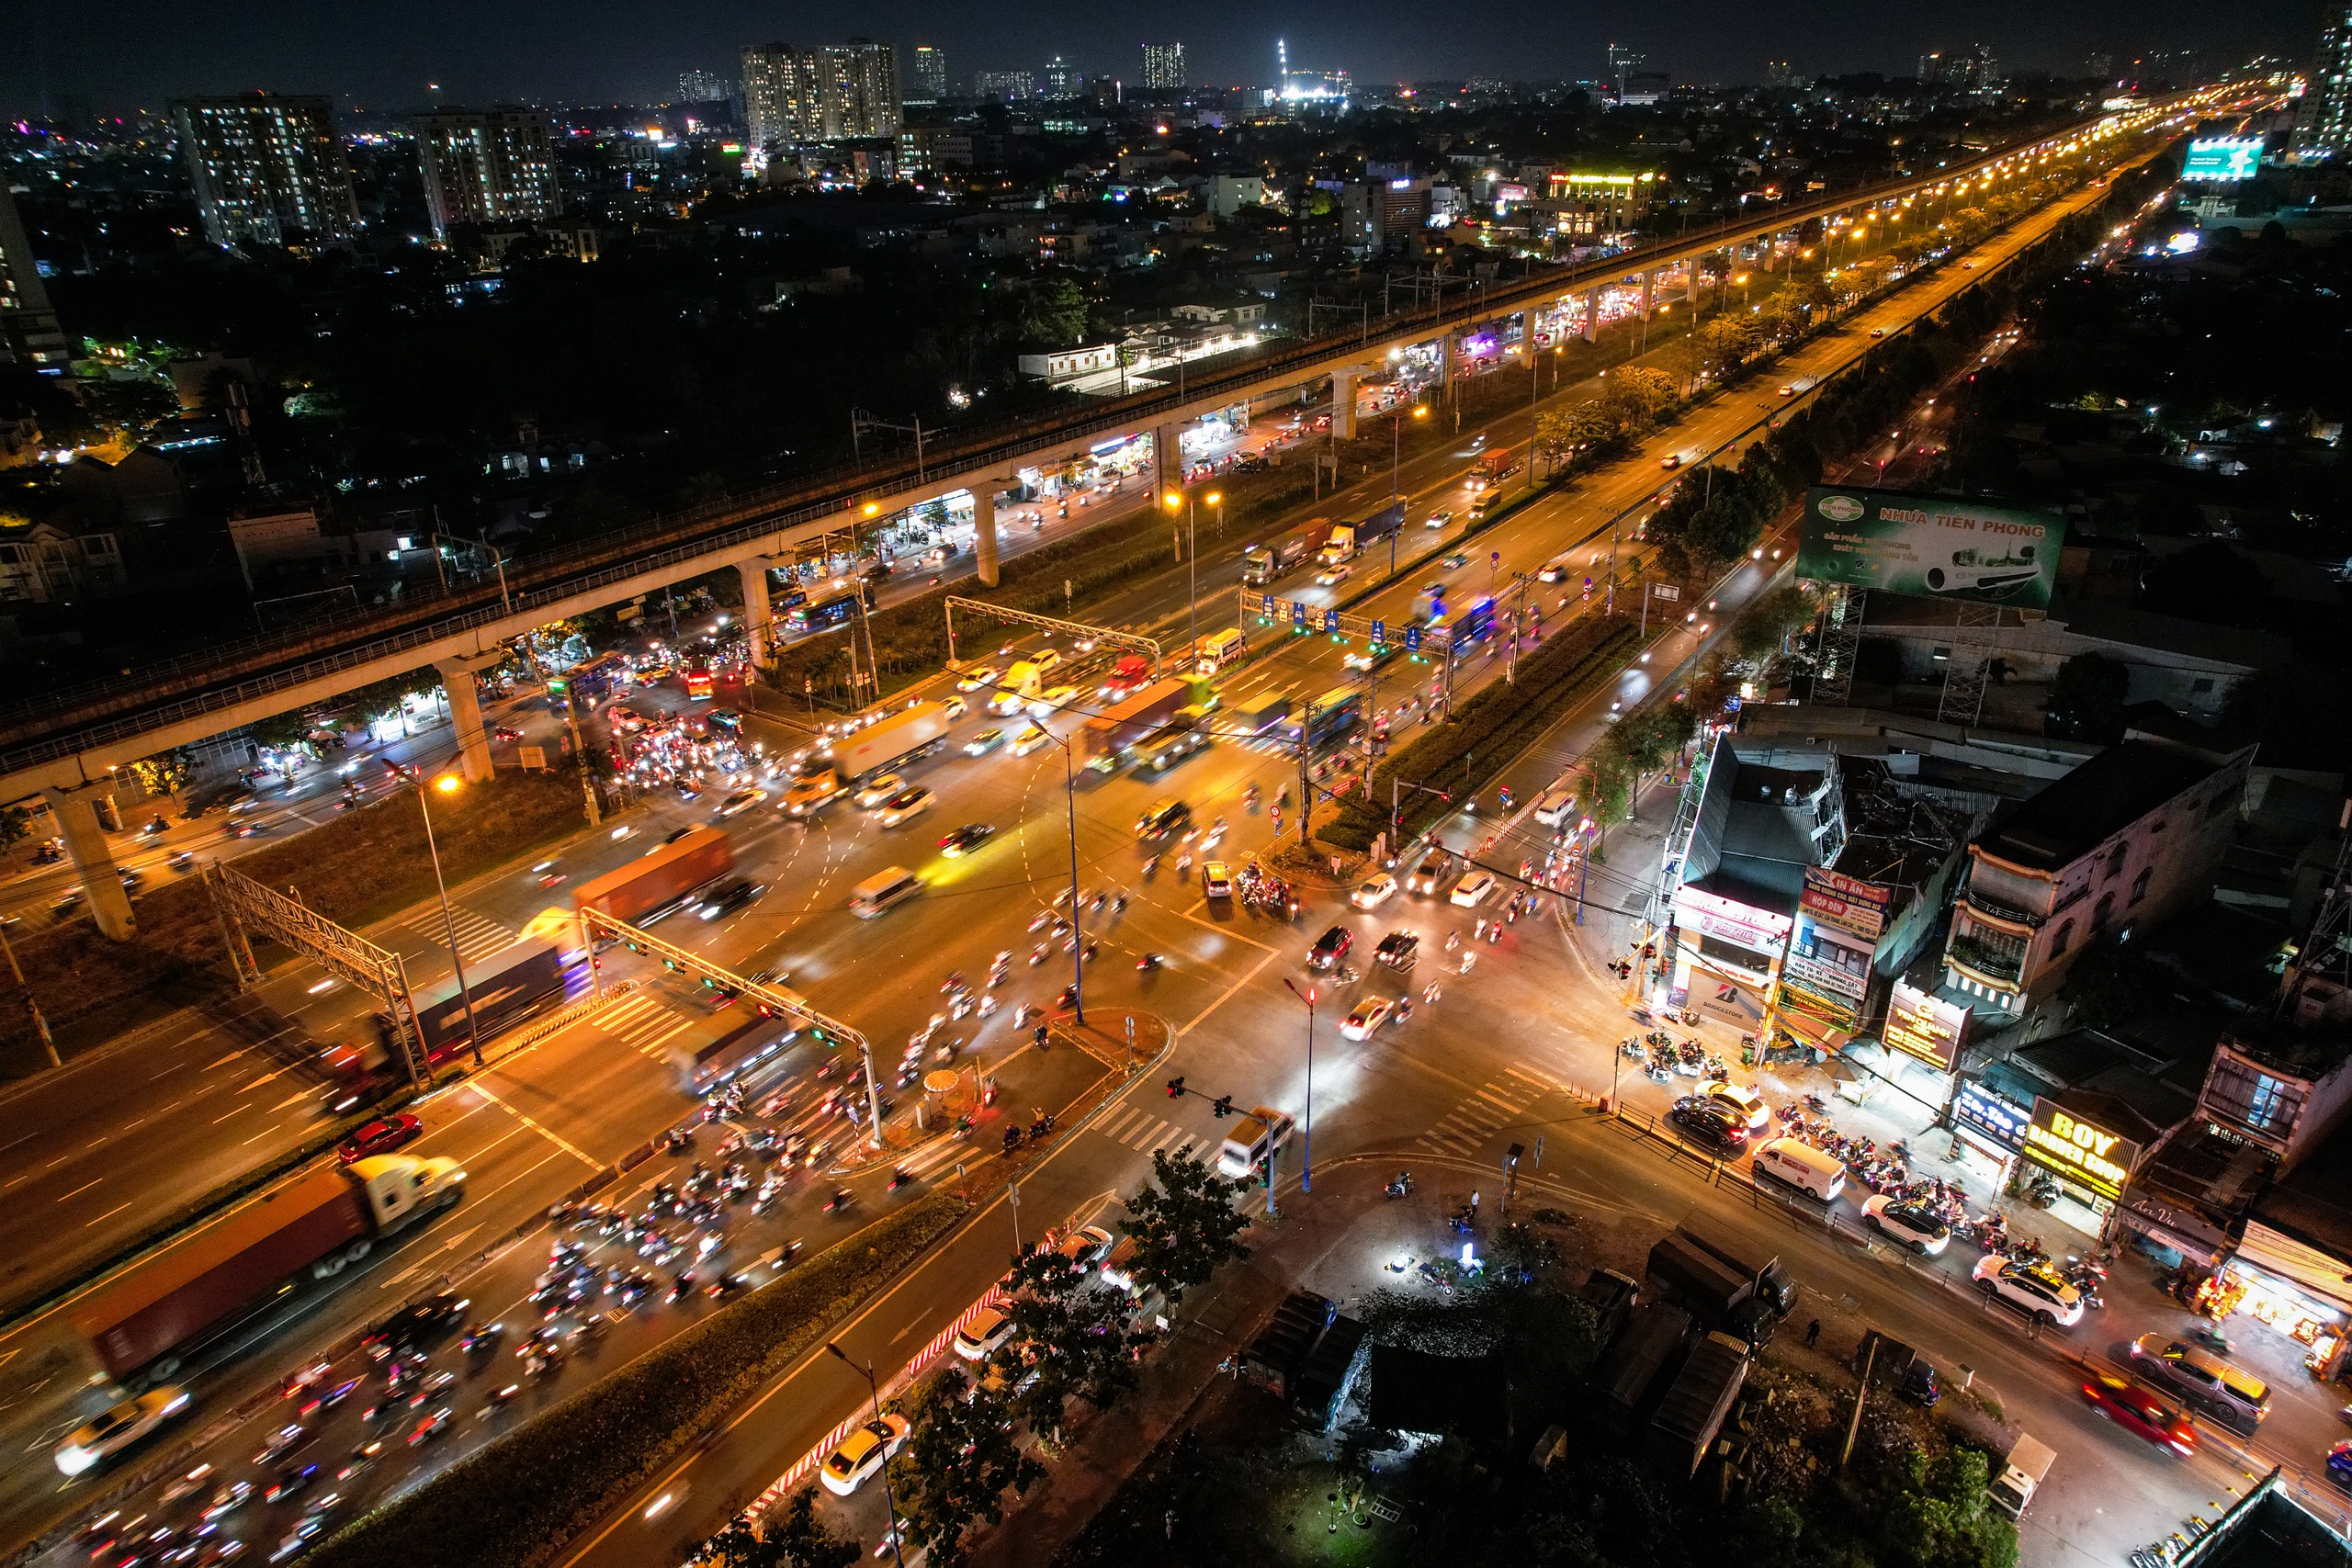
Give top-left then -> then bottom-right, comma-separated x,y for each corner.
1943,736 -> 2253,1016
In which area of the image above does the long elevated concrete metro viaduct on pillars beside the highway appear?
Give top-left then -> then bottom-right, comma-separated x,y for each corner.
0,94 -> 2201,938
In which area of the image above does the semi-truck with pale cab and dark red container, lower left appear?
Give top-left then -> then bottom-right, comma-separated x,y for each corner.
73,1155 -> 466,1387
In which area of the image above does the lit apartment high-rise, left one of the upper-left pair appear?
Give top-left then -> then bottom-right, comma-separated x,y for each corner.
172,92 -> 360,244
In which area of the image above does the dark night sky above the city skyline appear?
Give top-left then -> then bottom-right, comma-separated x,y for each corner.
0,0 -> 2319,115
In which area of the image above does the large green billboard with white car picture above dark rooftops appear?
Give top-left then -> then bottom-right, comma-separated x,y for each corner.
1797,484 -> 2065,609
